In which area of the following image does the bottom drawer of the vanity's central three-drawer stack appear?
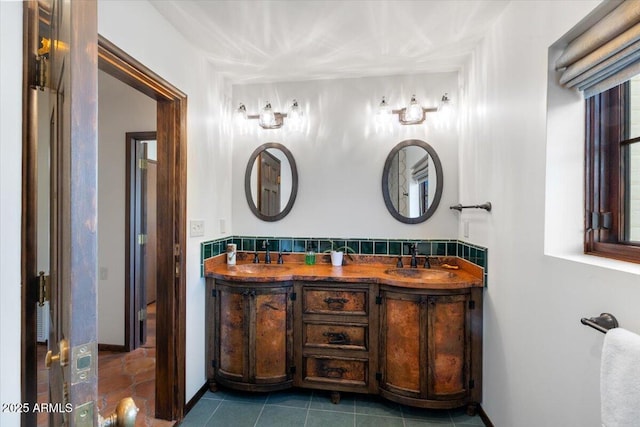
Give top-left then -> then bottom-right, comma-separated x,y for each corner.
304,356 -> 369,386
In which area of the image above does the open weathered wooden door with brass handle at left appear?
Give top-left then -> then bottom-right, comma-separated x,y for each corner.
48,0 -> 98,426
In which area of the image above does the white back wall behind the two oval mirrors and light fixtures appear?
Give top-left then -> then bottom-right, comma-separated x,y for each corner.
232,73 -> 458,239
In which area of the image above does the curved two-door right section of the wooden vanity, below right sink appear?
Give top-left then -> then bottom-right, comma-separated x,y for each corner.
378,286 -> 482,413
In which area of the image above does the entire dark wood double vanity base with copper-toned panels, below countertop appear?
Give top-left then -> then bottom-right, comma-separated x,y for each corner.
206,278 -> 483,414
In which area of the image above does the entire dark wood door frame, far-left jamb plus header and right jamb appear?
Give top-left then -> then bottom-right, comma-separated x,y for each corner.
21,2 -> 186,425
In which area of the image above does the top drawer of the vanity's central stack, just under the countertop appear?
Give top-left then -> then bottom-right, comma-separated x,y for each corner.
303,288 -> 367,315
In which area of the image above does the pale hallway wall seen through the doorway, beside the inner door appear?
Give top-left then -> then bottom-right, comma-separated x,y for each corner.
98,71 -> 156,346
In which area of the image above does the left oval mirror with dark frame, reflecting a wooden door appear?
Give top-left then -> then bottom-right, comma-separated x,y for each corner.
244,142 -> 298,221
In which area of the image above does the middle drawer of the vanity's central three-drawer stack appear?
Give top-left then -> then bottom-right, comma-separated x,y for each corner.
303,323 -> 369,350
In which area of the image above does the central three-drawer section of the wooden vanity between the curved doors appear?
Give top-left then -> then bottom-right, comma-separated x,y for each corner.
294,282 -> 377,401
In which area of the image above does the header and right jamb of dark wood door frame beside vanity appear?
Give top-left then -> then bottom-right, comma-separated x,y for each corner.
98,36 -> 187,420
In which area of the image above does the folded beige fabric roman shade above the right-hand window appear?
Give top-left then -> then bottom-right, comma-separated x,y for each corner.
556,0 -> 640,97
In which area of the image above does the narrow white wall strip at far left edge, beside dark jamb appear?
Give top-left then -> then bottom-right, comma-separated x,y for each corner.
0,1 -> 22,426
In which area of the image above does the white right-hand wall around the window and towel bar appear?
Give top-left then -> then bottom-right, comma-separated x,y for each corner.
460,1 -> 640,427
